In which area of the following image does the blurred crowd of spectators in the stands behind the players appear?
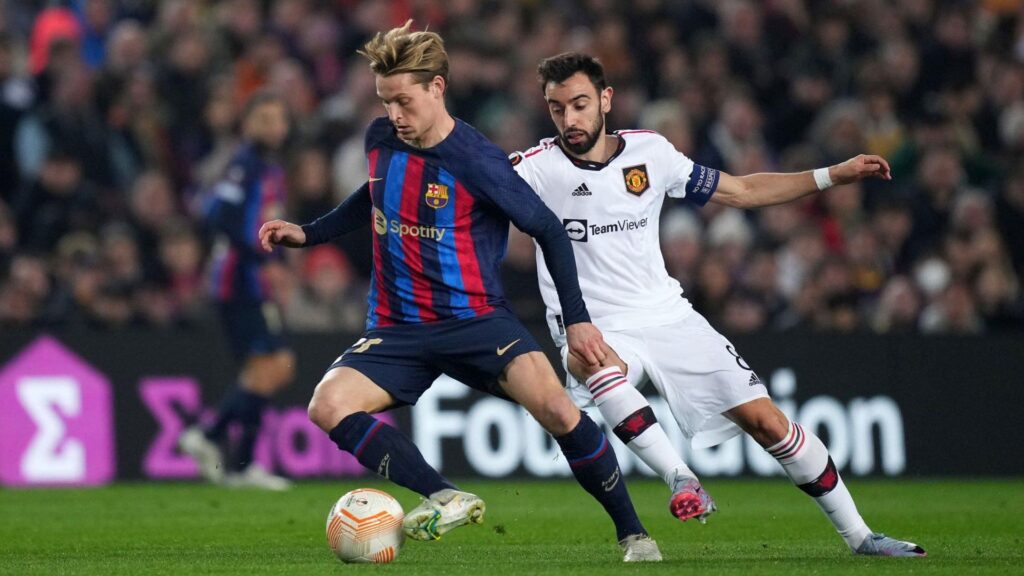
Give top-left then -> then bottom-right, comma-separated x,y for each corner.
0,0 -> 1024,334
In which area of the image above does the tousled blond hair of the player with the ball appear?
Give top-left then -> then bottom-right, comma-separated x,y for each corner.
358,19 -> 449,84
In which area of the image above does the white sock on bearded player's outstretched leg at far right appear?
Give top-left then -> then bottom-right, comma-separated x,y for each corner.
765,421 -> 871,550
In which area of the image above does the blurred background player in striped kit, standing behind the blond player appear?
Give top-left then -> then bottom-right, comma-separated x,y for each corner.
179,91 -> 295,490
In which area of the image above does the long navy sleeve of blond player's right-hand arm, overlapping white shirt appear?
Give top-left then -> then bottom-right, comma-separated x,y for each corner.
470,145 -> 590,325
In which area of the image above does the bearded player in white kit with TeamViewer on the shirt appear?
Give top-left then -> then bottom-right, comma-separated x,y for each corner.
510,53 -> 926,557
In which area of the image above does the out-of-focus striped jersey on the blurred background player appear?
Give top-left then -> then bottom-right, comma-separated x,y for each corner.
204,146 -> 285,300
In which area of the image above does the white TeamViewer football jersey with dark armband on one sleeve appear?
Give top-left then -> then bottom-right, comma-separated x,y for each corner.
509,130 -> 719,345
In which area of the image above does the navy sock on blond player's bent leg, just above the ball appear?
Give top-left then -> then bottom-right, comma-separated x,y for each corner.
330,412 -> 455,497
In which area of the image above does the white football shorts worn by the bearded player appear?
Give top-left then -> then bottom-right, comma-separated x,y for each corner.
561,311 -> 768,448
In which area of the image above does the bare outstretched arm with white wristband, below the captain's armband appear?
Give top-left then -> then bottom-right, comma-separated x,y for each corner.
711,154 -> 892,208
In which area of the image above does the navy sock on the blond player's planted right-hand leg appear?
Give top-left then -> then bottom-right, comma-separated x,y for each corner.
555,412 -> 647,541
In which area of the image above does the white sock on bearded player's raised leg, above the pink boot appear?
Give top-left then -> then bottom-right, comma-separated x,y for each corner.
587,366 -> 696,488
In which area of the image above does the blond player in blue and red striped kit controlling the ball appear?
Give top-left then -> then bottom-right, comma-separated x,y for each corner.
260,22 -> 662,562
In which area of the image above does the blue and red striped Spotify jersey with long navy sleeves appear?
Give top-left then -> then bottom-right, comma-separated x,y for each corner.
303,118 -> 589,329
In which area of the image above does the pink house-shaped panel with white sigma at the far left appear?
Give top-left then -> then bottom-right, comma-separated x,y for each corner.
0,336 -> 116,486
